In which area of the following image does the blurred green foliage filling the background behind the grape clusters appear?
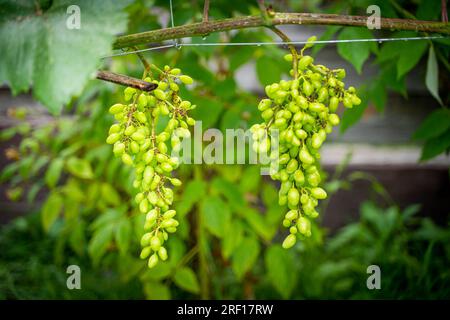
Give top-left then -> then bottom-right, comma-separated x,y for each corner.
0,0 -> 450,299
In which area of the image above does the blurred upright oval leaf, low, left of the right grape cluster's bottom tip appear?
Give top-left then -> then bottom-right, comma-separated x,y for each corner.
231,237 -> 260,280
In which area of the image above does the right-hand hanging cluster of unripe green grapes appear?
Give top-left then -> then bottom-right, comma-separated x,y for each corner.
251,37 -> 361,248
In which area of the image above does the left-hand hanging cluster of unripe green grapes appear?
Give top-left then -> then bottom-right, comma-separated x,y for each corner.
106,65 -> 195,268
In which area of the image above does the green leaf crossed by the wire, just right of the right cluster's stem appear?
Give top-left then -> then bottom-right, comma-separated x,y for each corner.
337,27 -> 376,73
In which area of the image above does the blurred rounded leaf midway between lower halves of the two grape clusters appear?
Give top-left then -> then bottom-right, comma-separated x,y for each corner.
201,196 -> 231,238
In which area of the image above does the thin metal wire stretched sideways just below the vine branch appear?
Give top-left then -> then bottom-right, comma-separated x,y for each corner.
103,36 -> 450,58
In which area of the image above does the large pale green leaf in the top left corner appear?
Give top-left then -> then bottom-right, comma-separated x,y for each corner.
0,0 -> 130,113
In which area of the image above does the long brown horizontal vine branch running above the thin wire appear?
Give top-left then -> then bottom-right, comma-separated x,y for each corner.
113,12 -> 450,49
